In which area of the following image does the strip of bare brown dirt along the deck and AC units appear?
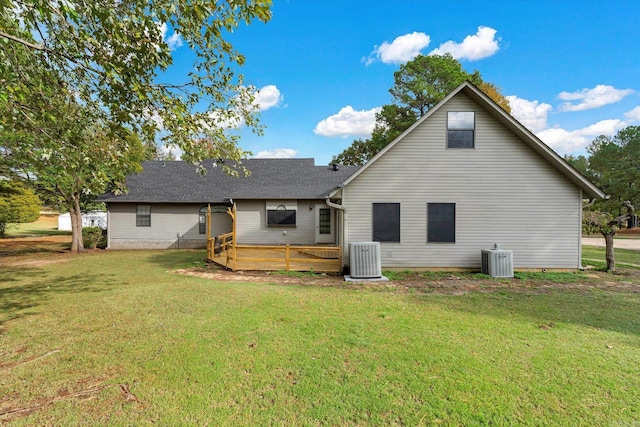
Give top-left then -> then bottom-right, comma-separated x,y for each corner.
174,266 -> 640,295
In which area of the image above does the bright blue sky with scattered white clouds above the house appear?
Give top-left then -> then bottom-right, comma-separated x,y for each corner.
164,0 -> 640,165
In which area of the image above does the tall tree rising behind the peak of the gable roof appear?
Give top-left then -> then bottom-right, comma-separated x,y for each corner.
331,53 -> 511,165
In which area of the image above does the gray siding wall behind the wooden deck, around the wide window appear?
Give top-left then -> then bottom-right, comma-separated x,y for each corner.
236,200 -> 324,245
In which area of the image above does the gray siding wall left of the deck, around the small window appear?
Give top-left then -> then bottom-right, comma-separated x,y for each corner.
108,203 -> 231,249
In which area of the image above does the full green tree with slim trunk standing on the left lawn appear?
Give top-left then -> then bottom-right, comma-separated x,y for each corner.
0,31 -> 145,251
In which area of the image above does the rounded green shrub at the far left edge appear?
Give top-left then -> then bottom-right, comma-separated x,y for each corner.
0,180 -> 40,237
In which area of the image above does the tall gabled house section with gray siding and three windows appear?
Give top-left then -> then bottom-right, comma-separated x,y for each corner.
330,82 -> 605,269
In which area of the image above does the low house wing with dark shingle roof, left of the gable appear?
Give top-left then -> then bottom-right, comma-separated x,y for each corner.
100,159 -> 357,249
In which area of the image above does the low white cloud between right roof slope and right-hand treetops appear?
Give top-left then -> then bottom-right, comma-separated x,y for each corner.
537,119 -> 627,155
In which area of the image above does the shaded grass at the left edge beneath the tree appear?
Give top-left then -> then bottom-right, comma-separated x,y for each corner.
0,267 -> 117,333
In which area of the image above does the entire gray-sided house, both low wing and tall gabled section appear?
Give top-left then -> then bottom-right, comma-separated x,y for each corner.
101,82 -> 605,269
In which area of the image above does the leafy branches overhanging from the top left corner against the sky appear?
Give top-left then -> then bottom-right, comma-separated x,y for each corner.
0,0 -> 271,161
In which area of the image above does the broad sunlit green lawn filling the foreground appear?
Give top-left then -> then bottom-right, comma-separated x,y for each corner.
0,251 -> 640,426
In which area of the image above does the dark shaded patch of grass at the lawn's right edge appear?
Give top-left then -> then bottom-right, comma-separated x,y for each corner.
416,287 -> 640,342
